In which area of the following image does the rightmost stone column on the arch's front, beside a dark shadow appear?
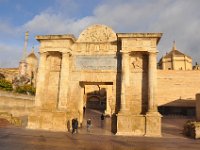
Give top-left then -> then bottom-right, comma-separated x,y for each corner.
148,52 -> 157,112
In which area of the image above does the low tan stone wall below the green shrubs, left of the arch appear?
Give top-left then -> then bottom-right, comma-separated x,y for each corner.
0,91 -> 35,116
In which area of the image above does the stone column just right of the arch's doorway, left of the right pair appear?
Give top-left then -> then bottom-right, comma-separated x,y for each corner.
120,52 -> 129,112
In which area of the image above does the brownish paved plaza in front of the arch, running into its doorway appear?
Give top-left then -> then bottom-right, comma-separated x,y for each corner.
0,111 -> 200,150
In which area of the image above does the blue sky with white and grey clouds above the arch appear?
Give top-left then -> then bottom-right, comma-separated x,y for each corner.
0,0 -> 200,67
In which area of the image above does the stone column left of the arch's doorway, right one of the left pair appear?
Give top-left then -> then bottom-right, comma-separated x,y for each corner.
58,53 -> 70,109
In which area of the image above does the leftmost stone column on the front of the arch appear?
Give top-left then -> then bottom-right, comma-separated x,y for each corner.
35,52 -> 47,107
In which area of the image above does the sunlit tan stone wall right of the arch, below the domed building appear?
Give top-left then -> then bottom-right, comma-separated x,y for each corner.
156,70 -> 200,107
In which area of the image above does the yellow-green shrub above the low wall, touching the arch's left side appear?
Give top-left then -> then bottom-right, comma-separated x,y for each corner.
16,85 -> 35,95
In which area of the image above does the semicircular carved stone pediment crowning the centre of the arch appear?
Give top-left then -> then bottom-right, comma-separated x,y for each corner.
78,25 -> 117,42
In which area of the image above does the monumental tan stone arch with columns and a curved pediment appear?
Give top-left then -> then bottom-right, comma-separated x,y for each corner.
28,24 -> 162,136
